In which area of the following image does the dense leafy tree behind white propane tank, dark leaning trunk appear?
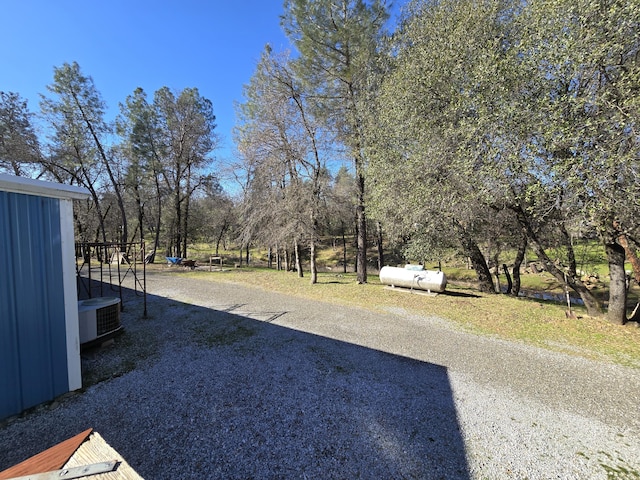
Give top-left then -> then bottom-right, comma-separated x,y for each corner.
367,1 -> 508,292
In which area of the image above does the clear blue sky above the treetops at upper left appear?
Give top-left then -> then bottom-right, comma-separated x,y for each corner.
0,0 -> 289,162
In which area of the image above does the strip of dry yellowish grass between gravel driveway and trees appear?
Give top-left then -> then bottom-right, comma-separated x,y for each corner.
184,268 -> 640,368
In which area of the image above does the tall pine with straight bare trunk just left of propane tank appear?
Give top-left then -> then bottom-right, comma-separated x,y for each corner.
282,0 -> 388,283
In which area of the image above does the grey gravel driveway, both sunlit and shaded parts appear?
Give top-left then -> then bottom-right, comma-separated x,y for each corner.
0,270 -> 640,480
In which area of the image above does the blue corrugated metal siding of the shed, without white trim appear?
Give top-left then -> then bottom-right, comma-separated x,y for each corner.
0,192 -> 69,418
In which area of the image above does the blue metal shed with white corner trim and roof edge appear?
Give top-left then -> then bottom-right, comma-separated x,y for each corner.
0,174 -> 89,419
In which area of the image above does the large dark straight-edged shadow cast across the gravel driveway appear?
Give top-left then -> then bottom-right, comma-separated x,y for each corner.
0,284 -> 470,479
